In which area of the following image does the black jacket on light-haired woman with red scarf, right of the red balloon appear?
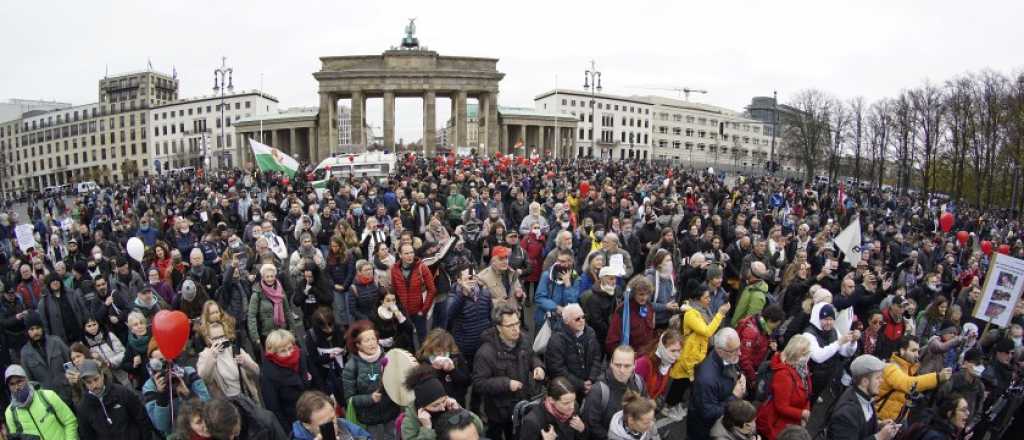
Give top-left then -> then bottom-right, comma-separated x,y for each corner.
259,352 -> 310,427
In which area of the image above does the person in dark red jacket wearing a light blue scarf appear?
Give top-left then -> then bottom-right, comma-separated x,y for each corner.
604,273 -> 654,355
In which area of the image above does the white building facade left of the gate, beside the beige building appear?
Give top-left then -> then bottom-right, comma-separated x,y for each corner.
150,90 -> 278,173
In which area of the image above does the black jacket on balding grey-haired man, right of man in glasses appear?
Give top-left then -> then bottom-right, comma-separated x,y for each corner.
544,325 -> 603,393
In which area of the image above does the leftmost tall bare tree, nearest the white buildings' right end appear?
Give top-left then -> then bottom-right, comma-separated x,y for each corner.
782,89 -> 835,182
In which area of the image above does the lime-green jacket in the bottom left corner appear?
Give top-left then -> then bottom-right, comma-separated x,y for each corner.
4,385 -> 78,440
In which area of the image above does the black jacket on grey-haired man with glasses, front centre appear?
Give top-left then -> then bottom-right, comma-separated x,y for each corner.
473,327 -> 542,421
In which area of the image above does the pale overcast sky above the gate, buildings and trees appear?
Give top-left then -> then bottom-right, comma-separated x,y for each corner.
0,0 -> 1024,140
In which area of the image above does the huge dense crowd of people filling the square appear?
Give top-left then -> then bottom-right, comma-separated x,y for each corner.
0,155 -> 1024,440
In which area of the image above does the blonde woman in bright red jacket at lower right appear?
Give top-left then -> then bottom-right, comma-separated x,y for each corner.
757,335 -> 811,440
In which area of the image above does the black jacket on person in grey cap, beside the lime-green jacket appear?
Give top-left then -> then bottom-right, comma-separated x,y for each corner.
77,384 -> 153,440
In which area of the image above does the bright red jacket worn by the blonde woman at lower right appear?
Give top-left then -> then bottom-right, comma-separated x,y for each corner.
757,353 -> 811,440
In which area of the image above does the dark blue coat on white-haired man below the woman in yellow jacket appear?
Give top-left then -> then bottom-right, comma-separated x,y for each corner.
686,349 -> 739,440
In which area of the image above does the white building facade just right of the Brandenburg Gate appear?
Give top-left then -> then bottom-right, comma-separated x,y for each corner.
534,89 -> 654,160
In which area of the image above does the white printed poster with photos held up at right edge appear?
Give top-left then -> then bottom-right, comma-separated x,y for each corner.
973,254 -> 1024,327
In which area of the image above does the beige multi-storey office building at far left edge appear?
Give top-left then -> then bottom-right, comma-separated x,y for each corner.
0,71 -> 178,194
